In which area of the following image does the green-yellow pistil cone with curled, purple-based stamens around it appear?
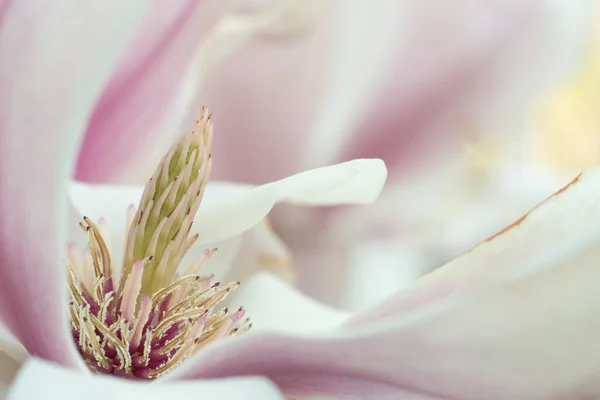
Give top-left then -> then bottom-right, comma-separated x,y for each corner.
67,108 -> 251,379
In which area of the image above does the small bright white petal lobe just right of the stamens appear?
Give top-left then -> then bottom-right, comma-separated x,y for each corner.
230,273 -> 350,334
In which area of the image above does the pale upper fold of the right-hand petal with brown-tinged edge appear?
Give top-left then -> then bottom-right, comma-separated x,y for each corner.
350,167 -> 600,323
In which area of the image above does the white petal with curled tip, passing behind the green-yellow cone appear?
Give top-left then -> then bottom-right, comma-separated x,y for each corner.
70,159 -> 387,248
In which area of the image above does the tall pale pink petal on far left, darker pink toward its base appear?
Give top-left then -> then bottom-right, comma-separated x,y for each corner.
0,0 -> 152,365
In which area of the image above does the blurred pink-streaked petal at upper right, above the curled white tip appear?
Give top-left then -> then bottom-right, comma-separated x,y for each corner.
339,0 -> 549,172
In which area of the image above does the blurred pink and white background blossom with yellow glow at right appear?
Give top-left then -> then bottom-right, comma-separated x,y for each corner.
79,0 -> 600,309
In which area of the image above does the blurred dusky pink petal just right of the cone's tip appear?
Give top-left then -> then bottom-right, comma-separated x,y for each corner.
203,2 -> 337,184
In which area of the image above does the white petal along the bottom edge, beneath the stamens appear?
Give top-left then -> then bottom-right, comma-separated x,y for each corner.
8,359 -> 284,400
